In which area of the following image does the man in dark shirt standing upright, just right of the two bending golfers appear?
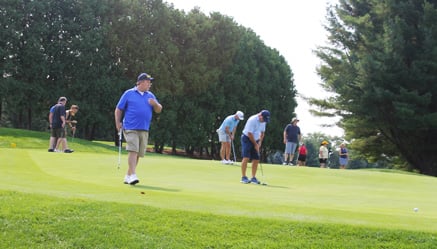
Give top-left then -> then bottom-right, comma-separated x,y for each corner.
282,118 -> 301,166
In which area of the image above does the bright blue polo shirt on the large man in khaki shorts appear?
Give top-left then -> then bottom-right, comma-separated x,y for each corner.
117,87 -> 158,131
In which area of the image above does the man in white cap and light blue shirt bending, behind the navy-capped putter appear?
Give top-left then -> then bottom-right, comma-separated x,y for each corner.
217,111 -> 244,164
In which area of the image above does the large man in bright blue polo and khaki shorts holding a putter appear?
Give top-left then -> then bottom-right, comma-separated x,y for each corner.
115,73 -> 162,185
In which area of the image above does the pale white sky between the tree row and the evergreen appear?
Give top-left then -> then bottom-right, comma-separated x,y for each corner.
164,0 -> 344,136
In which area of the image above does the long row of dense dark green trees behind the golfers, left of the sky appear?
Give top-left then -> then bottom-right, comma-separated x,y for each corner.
0,0 -> 296,158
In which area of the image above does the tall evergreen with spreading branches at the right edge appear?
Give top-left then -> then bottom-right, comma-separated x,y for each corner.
313,0 -> 437,176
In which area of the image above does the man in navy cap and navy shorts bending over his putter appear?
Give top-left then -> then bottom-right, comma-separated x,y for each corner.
241,110 -> 270,184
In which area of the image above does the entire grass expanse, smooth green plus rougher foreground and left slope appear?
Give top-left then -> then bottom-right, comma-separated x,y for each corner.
0,128 -> 437,248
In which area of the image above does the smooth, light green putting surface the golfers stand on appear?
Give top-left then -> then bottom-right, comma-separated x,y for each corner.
0,148 -> 437,232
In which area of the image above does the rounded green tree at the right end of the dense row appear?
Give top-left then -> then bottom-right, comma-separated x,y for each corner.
222,28 -> 297,158
